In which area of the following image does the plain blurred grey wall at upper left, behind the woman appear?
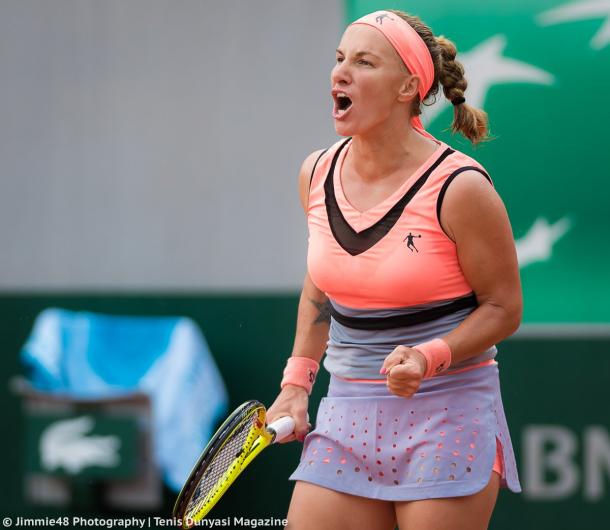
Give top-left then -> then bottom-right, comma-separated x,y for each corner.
0,0 -> 343,291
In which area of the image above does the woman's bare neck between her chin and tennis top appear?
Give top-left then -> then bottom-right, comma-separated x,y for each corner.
348,125 -> 437,181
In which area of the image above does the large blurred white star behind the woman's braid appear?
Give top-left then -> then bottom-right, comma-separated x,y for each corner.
423,35 -> 555,124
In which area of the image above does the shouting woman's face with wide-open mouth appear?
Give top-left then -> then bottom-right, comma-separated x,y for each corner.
331,24 -> 418,136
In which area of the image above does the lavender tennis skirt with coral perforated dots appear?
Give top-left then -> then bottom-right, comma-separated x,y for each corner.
290,364 -> 521,501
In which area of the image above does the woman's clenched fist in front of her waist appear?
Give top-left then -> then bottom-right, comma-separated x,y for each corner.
379,346 -> 427,397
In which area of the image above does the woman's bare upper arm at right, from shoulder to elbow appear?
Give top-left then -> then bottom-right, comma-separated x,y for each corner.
440,171 -> 522,320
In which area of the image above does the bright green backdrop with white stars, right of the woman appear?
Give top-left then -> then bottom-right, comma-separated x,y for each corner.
346,0 -> 610,322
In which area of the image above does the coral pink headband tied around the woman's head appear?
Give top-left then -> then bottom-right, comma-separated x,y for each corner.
352,11 -> 434,136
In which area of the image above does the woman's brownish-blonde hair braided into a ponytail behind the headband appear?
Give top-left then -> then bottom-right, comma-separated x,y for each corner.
388,9 -> 489,145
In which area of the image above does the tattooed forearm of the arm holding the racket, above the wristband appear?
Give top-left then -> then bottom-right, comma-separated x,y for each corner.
292,274 -> 330,362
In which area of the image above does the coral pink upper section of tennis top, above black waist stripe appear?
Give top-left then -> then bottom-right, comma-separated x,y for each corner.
307,138 -> 489,309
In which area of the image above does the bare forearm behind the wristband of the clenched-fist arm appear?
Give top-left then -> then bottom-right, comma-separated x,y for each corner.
442,302 -> 521,365
